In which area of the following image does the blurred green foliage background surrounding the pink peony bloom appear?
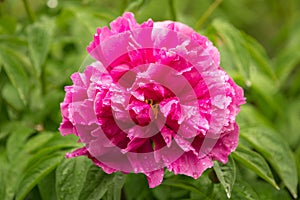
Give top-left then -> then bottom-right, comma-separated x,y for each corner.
0,0 -> 300,200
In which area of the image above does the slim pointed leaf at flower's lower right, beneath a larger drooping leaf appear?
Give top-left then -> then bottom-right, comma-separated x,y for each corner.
233,145 -> 279,190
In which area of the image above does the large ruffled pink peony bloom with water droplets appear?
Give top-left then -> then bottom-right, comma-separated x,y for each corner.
59,13 -> 245,187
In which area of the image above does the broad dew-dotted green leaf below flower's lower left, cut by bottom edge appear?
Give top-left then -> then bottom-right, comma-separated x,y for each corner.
56,157 -> 91,200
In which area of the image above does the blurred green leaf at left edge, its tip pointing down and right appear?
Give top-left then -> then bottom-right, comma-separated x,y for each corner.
0,46 -> 29,105
